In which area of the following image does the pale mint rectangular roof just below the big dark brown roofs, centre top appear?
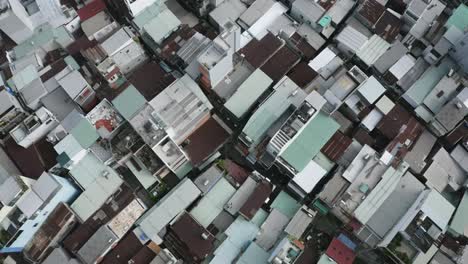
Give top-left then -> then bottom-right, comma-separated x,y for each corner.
224,69 -> 273,118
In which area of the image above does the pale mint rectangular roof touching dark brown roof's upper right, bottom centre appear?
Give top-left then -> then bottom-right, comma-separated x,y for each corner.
190,178 -> 236,228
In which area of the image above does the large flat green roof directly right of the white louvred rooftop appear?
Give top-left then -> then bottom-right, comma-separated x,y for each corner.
280,112 -> 340,171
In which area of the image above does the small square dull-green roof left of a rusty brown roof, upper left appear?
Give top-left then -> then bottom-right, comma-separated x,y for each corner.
112,85 -> 146,120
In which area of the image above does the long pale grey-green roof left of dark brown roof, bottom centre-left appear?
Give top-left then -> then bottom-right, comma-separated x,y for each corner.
139,178 -> 201,244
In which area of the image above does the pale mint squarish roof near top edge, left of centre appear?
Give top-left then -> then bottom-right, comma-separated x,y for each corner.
143,9 -> 181,44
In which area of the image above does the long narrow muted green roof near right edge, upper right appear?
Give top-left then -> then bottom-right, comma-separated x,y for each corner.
403,57 -> 455,107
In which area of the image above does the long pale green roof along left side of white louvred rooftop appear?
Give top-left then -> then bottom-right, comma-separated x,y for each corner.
242,77 -> 306,145
